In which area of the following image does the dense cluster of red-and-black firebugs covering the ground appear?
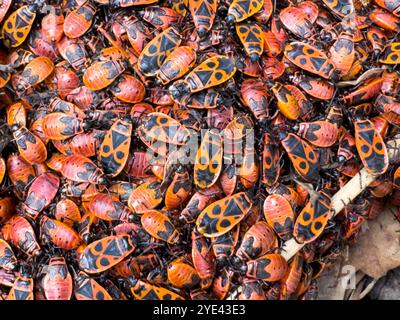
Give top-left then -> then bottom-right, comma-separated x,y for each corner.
0,0 -> 400,300
